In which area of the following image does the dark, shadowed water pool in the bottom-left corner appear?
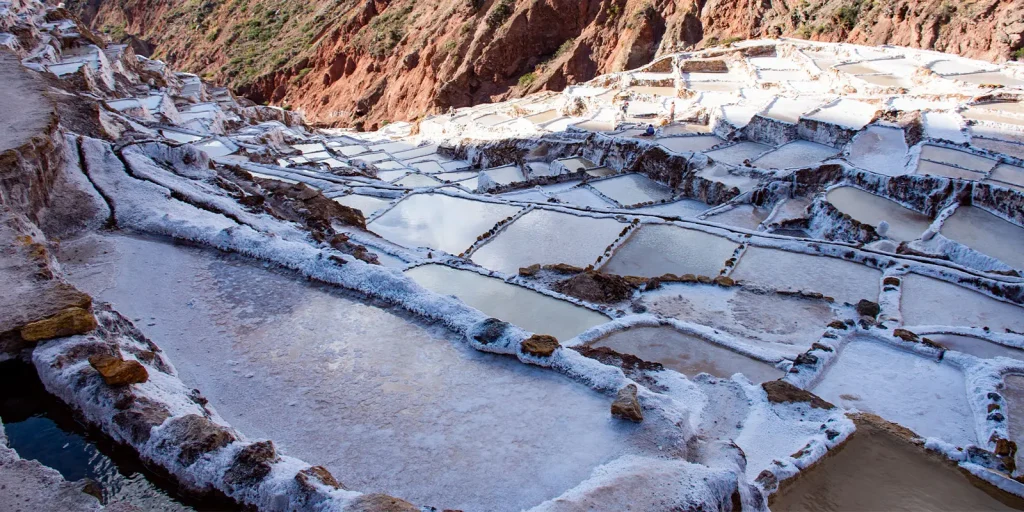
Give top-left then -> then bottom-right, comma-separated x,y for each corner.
0,361 -> 241,512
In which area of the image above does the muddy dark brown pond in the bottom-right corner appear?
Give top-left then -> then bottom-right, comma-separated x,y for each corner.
770,424 -> 1024,512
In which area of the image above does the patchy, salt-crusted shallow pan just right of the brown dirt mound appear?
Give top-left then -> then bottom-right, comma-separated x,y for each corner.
641,284 -> 835,358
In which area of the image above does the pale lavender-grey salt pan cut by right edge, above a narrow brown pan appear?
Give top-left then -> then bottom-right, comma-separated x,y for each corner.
900,274 -> 1024,333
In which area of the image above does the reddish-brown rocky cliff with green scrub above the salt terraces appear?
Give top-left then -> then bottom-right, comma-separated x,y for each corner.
72,0 -> 1024,129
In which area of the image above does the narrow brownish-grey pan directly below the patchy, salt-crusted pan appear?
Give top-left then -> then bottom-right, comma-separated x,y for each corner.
590,327 -> 782,383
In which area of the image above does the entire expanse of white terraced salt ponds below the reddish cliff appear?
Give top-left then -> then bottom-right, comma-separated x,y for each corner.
0,3 -> 1024,511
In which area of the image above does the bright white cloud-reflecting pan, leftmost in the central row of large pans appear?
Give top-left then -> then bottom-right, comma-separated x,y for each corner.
472,210 -> 626,274
